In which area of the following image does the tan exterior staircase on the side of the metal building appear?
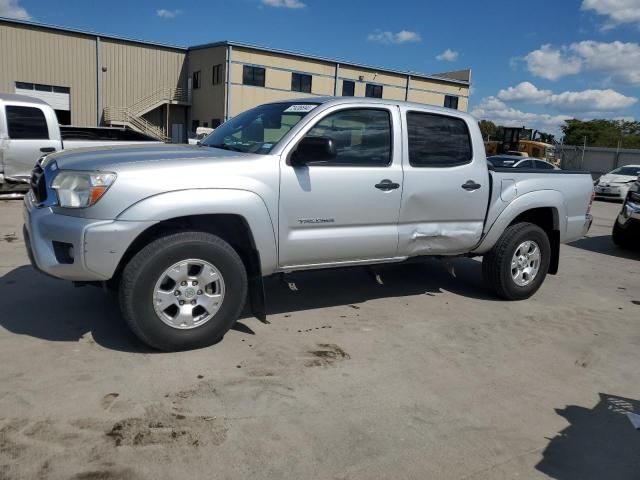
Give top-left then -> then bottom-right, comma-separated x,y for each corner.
104,87 -> 191,142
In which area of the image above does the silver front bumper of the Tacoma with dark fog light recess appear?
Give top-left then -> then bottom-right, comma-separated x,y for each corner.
23,193 -> 155,281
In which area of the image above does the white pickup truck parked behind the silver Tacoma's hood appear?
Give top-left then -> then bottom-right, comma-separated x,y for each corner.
0,93 -> 161,195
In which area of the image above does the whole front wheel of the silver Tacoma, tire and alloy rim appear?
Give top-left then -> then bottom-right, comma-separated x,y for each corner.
119,232 -> 247,351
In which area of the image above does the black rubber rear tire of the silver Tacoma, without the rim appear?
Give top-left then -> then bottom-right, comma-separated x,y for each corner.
482,222 -> 551,300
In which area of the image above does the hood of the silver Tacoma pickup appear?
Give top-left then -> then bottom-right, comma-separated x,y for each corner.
46,144 -> 245,173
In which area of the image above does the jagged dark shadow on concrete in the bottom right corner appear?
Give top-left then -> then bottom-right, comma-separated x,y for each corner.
536,393 -> 640,480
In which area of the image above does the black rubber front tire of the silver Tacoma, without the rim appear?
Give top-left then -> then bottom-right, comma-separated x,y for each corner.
119,232 -> 247,351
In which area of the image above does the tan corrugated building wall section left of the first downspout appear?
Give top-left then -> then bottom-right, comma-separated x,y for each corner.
0,22 -> 96,126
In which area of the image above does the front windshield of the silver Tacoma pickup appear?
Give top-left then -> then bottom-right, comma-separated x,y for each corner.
201,102 -> 318,154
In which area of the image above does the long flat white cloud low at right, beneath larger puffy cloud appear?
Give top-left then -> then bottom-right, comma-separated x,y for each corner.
496,82 -> 638,113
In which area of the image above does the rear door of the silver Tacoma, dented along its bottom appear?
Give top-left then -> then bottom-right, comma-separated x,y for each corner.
398,108 -> 490,256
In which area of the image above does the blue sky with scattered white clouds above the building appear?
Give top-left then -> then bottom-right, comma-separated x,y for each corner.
0,0 -> 640,131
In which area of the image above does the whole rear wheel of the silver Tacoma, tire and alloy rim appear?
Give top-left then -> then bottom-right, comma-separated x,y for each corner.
482,222 -> 551,300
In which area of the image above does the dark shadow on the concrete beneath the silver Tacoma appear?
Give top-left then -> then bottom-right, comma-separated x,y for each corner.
0,258 -> 498,353
